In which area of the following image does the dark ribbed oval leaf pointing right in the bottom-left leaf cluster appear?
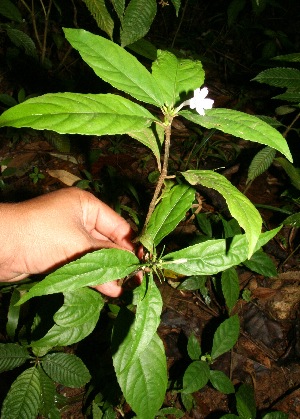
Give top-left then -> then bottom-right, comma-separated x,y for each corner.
42,352 -> 91,388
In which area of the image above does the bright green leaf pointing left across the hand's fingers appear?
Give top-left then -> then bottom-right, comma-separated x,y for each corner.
18,249 -> 139,304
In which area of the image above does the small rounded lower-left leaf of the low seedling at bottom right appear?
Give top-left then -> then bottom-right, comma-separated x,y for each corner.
182,361 -> 209,393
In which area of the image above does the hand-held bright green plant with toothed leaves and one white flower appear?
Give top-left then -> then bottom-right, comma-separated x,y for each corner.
0,29 -> 292,419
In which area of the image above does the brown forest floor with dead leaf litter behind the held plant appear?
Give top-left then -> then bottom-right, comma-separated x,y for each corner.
0,1 -> 300,419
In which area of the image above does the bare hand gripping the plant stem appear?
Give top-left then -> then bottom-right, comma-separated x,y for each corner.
0,187 -> 139,297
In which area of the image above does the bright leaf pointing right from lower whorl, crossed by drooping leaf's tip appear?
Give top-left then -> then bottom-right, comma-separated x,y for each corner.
160,227 -> 281,276
